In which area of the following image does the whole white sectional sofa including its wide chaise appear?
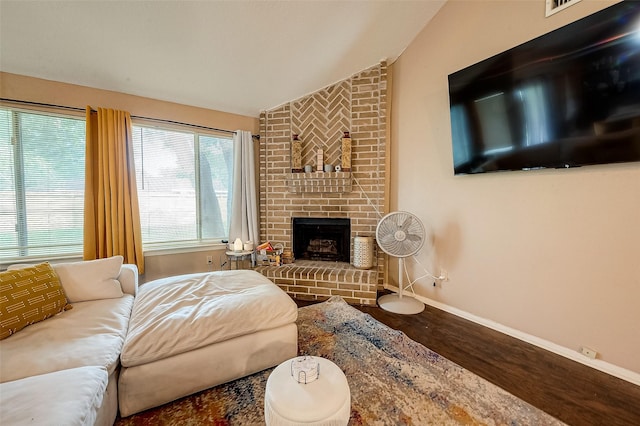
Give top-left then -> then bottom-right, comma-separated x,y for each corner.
0,256 -> 298,426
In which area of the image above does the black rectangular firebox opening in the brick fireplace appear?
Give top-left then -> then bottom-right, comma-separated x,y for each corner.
292,217 -> 351,263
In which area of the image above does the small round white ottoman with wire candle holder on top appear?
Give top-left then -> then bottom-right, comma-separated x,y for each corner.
264,357 -> 351,426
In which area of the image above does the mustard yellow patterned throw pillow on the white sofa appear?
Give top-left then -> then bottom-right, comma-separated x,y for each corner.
0,263 -> 71,340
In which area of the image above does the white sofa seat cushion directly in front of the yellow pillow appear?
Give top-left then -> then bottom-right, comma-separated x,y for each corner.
0,295 -> 133,382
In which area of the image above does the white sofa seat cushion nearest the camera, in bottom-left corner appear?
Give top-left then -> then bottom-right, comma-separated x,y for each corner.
0,367 -> 107,426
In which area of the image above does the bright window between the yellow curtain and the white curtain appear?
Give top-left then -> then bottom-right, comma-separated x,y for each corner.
133,126 -> 233,248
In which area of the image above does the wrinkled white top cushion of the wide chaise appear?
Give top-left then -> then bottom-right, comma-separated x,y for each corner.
120,270 -> 298,367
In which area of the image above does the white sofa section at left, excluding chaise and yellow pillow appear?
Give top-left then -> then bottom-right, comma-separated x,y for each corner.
0,256 -> 138,425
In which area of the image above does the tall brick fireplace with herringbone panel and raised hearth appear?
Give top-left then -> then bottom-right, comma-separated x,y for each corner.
257,62 -> 388,305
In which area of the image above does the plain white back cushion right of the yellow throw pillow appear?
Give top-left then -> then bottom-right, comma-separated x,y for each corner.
53,256 -> 123,303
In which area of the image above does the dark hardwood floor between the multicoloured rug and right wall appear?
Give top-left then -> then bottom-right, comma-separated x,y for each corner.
296,301 -> 640,426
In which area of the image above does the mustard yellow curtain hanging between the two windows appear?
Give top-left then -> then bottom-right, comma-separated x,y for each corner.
83,107 -> 144,274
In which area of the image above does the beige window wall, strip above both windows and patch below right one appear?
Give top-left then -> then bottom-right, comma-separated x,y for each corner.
0,73 -> 259,282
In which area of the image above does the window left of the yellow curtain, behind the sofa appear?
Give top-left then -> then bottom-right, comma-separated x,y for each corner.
0,108 -> 85,260
